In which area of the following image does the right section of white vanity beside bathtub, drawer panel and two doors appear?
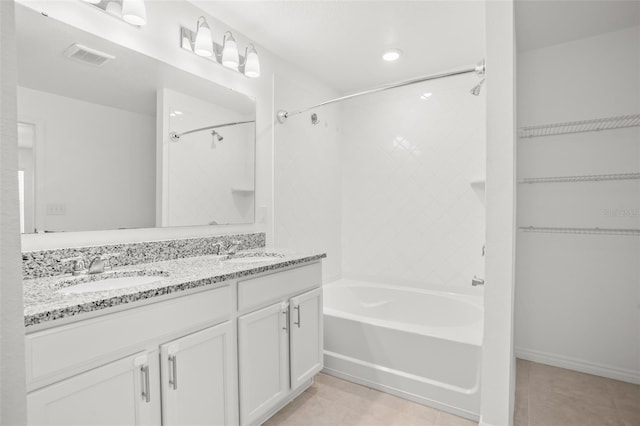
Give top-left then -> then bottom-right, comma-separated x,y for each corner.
238,263 -> 323,425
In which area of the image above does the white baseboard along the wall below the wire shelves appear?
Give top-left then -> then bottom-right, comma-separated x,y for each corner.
515,348 -> 640,384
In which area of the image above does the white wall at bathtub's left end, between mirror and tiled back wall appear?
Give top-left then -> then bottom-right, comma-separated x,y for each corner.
274,76 -> 343,282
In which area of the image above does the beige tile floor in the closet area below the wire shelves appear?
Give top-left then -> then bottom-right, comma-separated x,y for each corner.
514,359 -> 640,426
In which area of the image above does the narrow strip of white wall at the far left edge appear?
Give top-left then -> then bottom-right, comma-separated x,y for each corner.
0,0 -> 27,425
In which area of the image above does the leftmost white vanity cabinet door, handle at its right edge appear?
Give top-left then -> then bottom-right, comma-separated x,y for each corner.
27,352 -> 160,426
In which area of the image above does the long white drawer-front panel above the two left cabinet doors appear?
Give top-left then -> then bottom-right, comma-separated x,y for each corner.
25,286 -> 233,389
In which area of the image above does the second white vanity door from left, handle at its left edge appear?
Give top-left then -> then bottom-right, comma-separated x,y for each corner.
160,322 -> 238,426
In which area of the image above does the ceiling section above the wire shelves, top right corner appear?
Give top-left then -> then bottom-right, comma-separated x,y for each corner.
515,0 -> 640,51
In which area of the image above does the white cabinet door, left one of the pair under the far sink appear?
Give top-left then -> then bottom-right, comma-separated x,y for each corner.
238,302 -> 289,425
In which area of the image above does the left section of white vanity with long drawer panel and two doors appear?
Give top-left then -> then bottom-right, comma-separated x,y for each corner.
26,286 -> 238,426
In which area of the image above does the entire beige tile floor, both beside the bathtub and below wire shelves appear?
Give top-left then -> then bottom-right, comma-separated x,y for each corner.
265,359 -> 640,426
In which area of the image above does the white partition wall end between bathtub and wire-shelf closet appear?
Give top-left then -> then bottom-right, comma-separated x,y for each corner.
480,0 -> 516,426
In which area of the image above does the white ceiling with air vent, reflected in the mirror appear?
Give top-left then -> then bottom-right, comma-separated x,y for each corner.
15,4 -> 255,115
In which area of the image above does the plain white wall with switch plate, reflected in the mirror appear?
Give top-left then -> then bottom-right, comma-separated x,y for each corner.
18,87 -> 155,231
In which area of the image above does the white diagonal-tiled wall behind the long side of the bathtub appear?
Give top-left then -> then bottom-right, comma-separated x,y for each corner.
342,75 -> 485,289
